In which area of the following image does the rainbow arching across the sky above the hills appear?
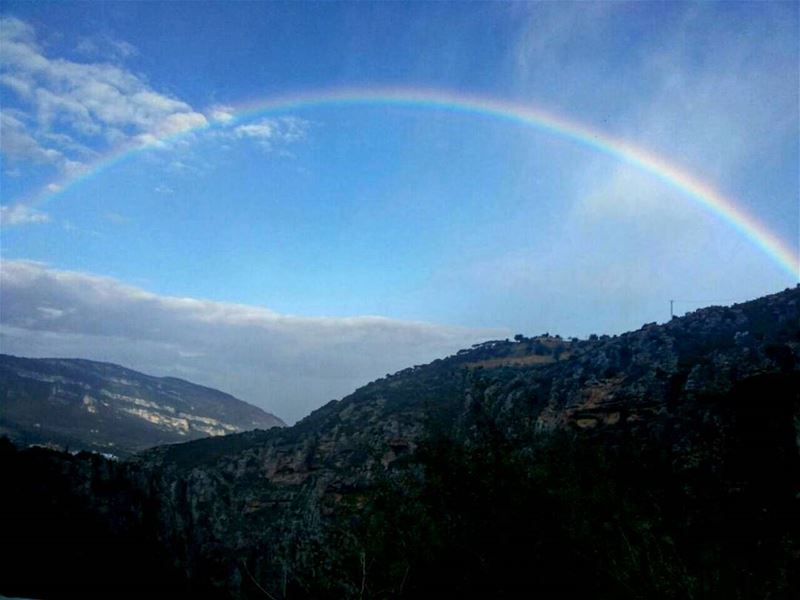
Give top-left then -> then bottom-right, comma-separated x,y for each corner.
7,88 -> 800,281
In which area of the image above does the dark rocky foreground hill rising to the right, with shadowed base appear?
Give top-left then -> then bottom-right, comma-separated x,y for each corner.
0,288 -> 800,598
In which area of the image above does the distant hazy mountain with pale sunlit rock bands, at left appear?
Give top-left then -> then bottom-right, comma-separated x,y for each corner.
0,354 -> 285,457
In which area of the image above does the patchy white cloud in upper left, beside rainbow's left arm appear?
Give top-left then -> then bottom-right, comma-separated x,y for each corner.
0,17 -> 208,176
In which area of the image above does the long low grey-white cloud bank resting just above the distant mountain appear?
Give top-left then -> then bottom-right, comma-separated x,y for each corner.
0,261 -> 500,421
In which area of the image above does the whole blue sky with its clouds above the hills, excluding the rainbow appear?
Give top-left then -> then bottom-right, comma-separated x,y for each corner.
0,2 -> 800,421
